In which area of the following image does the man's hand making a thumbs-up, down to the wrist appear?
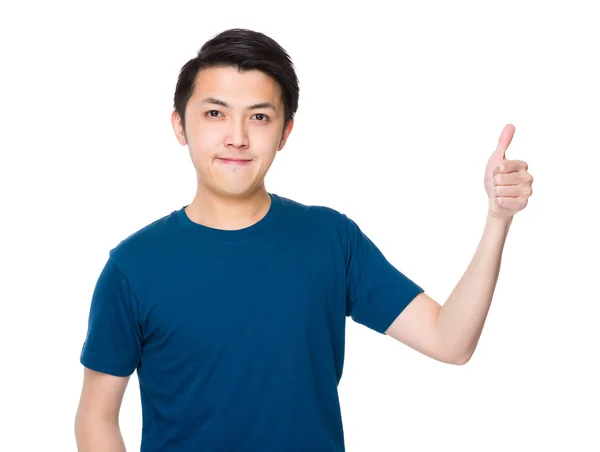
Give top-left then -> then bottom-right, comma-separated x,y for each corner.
483,124 -> 533,221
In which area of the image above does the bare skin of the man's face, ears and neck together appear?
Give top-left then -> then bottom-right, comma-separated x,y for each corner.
171,67 -> 294,230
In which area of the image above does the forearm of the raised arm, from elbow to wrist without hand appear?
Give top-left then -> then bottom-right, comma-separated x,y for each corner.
436,215 -> 512,363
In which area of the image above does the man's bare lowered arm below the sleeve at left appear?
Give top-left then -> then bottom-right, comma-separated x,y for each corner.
75,368 -> 129,452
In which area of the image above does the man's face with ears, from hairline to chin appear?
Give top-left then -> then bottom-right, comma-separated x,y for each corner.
171,67 -> 293,200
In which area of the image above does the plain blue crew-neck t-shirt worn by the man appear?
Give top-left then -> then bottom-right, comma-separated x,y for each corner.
80,193 -> 423,452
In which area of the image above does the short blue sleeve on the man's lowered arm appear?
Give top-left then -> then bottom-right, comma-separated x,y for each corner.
80,258 -> 142,377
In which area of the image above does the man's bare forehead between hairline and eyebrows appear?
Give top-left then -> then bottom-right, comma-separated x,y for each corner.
192,67 -> 281,105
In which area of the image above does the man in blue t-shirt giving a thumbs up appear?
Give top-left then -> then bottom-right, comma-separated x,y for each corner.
75,29 -> 532,452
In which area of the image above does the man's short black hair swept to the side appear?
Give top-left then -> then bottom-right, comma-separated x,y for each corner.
173,28 -> 300,134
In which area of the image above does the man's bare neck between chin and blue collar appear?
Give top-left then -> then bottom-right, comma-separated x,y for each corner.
185,185 -> 271,230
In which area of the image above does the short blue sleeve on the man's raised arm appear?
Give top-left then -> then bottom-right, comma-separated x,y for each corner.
344,215 -> 424,334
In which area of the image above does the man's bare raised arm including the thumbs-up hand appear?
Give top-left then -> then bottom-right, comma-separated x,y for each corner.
386,124 -> 533,364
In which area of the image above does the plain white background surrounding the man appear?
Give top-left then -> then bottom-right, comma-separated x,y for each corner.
0,0 -> 600,452
